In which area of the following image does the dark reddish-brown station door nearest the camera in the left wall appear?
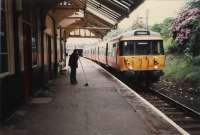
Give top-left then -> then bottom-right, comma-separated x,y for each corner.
23,23 -> 32,100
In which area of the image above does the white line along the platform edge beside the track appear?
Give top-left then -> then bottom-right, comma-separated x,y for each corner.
89,59 -> 190,135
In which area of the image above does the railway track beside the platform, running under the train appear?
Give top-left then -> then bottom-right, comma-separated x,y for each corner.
104,67 -> 200,135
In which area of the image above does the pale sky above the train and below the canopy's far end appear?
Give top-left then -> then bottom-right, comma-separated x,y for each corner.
67,0 -> 186,46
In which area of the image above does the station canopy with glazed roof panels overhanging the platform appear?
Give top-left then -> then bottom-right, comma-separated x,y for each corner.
35,0 -> 144,38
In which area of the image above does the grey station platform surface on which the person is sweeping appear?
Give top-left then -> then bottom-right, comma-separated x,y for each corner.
0,58 -> 183,135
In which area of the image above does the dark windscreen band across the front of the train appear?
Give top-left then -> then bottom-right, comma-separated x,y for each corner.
120,40 -> 164,56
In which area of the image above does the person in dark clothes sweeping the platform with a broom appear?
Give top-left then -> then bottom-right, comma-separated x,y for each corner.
68,50 -> 79,84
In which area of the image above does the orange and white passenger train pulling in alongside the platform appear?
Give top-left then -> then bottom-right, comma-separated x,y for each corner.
83,30 -> 166,83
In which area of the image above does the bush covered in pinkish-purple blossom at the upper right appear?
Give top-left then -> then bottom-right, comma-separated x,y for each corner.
171,0 -> 200,57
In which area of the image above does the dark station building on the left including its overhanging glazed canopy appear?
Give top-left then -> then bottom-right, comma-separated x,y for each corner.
0,0 -> 143,122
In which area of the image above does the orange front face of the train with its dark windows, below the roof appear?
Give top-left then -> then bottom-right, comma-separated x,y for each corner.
118,38 -> 165,79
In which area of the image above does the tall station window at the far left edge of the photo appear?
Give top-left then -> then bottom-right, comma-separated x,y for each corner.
0,0 -> 8,73
